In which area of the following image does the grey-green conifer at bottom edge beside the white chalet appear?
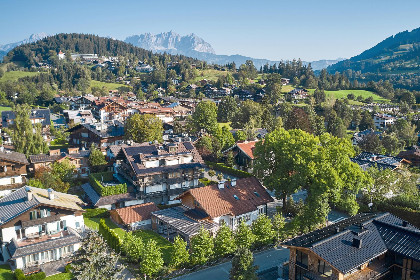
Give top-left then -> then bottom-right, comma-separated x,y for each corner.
71,231 -> 124,280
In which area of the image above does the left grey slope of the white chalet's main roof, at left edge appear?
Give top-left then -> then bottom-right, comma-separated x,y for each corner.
0,187 -> 40,226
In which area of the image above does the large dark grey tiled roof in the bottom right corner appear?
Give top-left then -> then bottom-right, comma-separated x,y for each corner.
284,213 -> 420,273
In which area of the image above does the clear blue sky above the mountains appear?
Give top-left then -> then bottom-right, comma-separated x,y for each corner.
0,0 -> 420,60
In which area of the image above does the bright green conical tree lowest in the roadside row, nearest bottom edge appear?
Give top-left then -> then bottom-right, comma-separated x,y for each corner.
140,239 -> 163,277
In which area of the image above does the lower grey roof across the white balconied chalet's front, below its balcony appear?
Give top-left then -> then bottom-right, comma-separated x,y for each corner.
8,229 -> 81,259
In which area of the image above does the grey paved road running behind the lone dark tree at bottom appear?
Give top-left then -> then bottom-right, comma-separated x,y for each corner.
173,248 -> 289,280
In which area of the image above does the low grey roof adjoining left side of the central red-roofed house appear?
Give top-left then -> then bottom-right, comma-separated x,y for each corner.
152,206 -> 218,238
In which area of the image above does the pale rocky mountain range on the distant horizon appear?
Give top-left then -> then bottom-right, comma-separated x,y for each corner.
124,31 -> 343,70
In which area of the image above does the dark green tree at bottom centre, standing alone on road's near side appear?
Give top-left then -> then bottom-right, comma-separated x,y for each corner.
229,248 -> 258,280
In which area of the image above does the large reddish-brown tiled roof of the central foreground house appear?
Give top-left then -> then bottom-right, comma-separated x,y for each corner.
180,177 -> 273,218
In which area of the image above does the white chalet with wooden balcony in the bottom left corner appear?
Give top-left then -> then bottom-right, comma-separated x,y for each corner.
0,186 -> 84,273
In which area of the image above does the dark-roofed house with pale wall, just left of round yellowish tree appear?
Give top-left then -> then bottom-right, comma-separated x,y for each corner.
67,123 -> 124,152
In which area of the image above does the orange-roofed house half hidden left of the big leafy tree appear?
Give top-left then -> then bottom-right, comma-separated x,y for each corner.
223,140 -> 259,172
